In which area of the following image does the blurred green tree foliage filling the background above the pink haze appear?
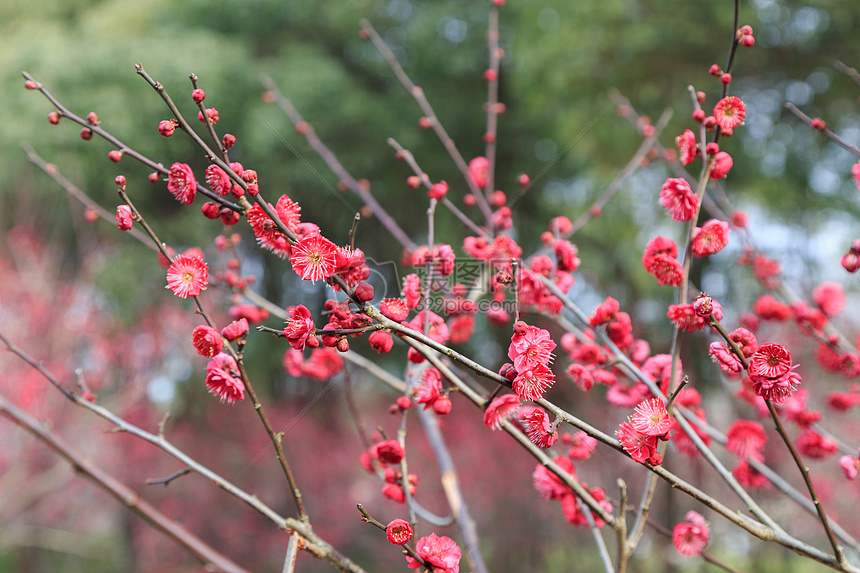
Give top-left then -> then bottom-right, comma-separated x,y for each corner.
0,0 -> 860,568
